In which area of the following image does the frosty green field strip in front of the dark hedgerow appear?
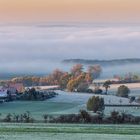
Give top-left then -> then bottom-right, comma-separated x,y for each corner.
0,123 -> 140,140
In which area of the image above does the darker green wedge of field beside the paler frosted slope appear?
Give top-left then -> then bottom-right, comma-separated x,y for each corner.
0,101 -> 80,120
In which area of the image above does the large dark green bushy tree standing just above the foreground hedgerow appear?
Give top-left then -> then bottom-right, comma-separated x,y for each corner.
87,96 -> 105,113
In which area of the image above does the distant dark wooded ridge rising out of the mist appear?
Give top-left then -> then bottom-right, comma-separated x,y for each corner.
62,58 -> 140,66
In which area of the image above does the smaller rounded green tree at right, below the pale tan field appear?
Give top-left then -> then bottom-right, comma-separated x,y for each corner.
116,85 -> 130,98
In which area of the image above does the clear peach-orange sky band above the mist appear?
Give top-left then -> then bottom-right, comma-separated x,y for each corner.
0,0 -> 140,23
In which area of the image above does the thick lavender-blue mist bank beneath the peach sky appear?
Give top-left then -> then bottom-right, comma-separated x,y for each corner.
0,24 -> 140,77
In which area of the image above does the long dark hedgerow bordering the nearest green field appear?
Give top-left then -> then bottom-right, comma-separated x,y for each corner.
0,110 -> 140,124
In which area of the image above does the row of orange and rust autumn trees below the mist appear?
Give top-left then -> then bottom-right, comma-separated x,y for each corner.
3,64 -> 102,91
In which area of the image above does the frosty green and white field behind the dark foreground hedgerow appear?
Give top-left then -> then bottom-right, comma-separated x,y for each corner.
0,92 -> 140,120
